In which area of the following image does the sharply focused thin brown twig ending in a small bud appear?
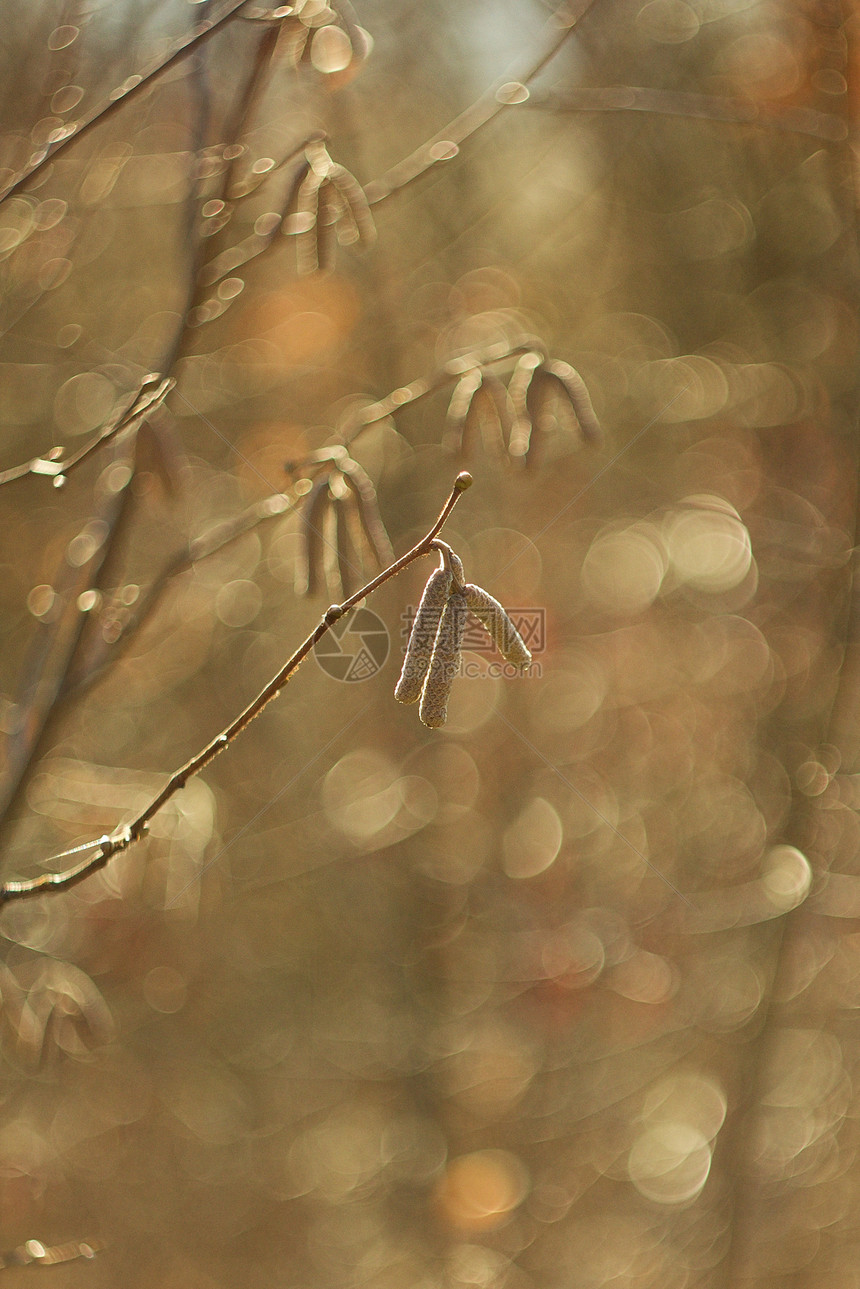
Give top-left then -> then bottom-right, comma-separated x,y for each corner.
0,472 -> 472,906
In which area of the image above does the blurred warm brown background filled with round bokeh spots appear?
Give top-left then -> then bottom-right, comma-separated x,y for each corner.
0,0 -> 860,1289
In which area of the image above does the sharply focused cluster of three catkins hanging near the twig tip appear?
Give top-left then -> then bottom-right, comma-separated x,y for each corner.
395,549 -> 531,730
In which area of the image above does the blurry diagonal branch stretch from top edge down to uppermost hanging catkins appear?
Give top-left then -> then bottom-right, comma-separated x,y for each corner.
365,0 -> 594,206
